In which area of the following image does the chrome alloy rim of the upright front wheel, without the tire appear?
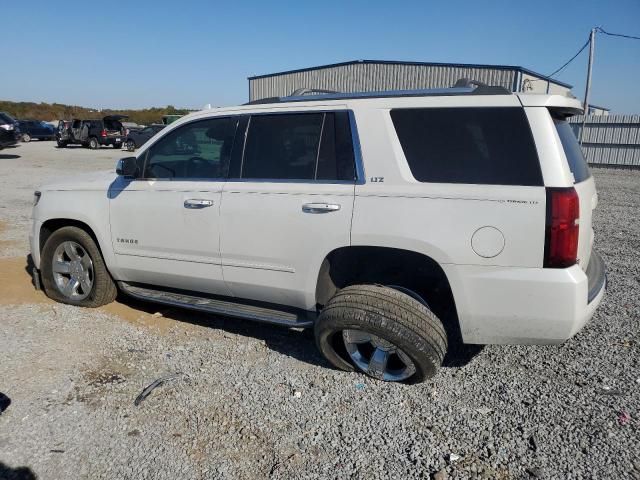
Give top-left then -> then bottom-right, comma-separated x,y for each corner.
51,241 -> 95,300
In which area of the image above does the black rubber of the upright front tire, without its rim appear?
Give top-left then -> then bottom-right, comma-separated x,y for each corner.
40,227 -> 118,308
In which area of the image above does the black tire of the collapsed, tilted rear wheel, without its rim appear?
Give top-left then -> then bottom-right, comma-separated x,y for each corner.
315,285 -> 448,383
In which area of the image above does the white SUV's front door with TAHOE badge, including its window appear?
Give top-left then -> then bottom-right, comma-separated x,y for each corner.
109,118 -> 237,295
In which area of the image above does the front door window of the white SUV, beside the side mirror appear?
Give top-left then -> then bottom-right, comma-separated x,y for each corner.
144,118 -> 237,179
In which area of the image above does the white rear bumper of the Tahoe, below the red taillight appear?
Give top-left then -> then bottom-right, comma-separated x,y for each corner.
443,251 -> 606,344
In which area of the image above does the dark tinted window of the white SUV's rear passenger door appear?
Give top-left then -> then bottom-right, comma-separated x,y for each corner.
241,112 -> 355,181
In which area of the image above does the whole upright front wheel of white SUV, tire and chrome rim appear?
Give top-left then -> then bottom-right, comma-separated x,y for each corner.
41,227 -> 118,307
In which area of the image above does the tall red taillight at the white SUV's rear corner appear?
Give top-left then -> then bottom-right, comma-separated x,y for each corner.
544,187 -> 580,268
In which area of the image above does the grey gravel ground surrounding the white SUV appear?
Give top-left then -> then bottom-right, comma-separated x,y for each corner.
0,142 -> 640,479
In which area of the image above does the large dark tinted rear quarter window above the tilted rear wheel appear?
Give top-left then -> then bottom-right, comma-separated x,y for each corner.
391,107 -> 542,186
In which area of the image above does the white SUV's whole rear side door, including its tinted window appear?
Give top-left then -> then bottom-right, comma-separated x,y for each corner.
221,111 -> 356,310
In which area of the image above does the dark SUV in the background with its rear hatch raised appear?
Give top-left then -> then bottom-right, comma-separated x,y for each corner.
56,115 -> 127,150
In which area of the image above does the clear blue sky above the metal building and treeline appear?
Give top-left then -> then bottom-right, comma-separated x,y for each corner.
0,0 -> 640,114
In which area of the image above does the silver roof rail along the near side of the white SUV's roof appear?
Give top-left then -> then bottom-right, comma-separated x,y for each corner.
245,78 -> 511,105
